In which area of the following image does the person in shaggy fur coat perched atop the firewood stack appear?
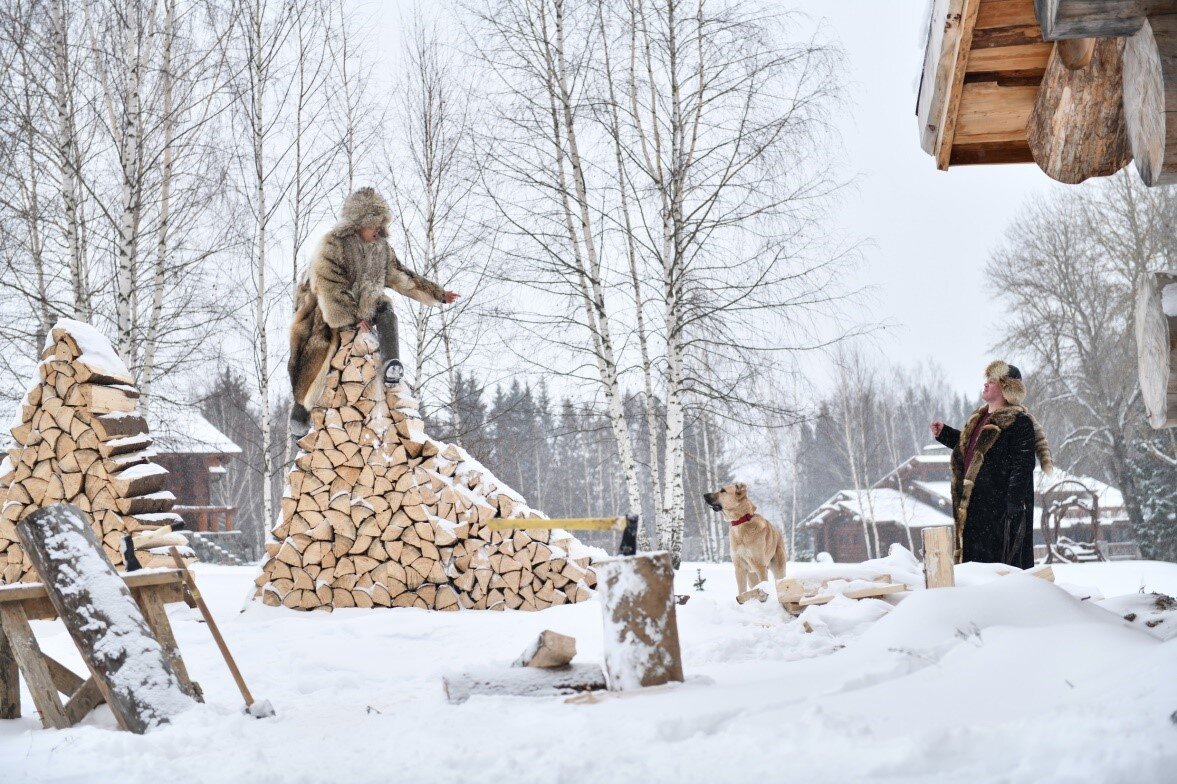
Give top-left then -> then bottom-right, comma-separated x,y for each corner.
288,188 -> 459,438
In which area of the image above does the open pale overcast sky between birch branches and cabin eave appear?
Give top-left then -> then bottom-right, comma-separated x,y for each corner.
809,0 -> 1058,392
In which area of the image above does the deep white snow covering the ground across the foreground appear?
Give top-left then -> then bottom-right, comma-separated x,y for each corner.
0,553 -> 1177,784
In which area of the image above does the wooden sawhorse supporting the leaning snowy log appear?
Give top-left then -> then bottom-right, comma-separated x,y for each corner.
0,569 -> 204,729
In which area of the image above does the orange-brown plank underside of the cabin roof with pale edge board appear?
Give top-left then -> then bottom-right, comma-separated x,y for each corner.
916,0 -> 1053,170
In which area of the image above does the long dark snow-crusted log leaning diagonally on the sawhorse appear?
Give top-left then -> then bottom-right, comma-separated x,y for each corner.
16,504 -> 194,733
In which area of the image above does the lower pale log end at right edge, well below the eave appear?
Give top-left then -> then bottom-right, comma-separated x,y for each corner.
1136,272 -> 1177,428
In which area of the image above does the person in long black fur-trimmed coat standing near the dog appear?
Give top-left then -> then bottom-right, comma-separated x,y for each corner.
931,361 -> 1052,569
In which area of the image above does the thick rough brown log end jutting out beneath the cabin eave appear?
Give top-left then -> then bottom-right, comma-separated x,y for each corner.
1026,38 -> 1132,185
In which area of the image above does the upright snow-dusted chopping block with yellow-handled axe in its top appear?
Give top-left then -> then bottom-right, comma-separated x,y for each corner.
598,551 -> 683,691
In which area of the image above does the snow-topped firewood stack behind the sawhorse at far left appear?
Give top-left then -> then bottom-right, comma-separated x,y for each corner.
0,319 -> 191,583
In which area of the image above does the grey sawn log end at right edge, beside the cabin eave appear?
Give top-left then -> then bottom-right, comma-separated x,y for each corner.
1124,14 -> 1177,186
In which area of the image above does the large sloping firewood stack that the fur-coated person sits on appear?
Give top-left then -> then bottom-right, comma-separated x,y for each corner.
258,332 -> 597,610
